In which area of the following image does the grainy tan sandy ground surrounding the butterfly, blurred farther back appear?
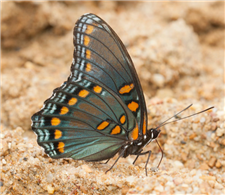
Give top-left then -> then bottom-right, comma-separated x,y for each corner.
0,0 -> 225,195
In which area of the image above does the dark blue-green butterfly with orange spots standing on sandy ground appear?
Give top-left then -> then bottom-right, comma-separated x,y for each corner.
31,13 -> 213,175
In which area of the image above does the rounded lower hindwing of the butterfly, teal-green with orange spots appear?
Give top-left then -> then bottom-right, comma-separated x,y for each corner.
32,77 -> 135,160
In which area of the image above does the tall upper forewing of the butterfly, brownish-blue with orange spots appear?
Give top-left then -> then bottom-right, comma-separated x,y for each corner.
72,14 -> 147,134
